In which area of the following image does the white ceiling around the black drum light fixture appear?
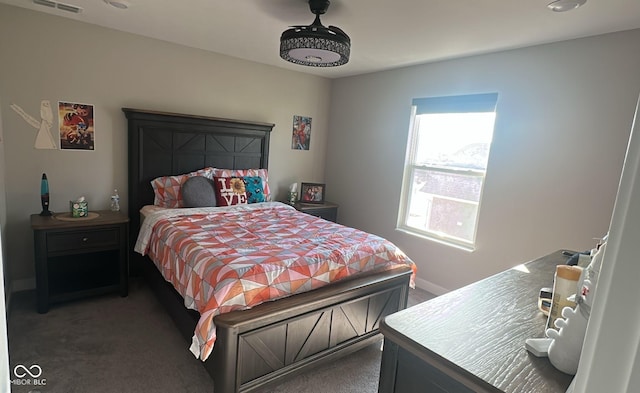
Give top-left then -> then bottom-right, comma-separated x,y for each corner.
0,0 -> 640,78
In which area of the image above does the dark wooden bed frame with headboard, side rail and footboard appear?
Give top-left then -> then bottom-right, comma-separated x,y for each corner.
122,108 -> 411,393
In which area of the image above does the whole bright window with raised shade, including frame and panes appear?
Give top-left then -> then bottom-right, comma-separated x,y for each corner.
398,93 -> 498,250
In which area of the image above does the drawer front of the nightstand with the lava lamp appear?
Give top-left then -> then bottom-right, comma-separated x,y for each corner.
47,228 -> 120,252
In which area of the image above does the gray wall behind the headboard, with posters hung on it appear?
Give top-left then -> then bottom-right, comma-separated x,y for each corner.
0,5 -> 330,289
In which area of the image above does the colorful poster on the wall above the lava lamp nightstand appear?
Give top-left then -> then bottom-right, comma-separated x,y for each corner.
58,102 -> 95,150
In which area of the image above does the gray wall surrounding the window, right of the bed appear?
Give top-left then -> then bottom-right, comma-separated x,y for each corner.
325,30 -> 640,292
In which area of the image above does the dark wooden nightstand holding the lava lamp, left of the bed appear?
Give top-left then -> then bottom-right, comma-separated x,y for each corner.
31,210 -> 129,313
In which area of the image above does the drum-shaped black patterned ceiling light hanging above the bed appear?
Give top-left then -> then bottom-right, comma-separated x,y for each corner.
280,0 -> 351,67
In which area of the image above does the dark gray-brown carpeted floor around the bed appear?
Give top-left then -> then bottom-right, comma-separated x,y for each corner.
8,280 -> 433,393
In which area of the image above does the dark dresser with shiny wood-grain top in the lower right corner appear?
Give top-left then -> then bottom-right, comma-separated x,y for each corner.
379,251 -> 573,393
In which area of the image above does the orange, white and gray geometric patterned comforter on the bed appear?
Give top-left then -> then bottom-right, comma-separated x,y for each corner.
135,202 -> 416,360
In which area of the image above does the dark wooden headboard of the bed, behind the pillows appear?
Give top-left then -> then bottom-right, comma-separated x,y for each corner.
122,108 -> 274,248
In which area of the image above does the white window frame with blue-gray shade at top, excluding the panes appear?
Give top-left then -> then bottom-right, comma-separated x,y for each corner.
396,93 -> 498,252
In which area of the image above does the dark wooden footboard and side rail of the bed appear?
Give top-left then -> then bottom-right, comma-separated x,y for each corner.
145,261 -> 411,393
